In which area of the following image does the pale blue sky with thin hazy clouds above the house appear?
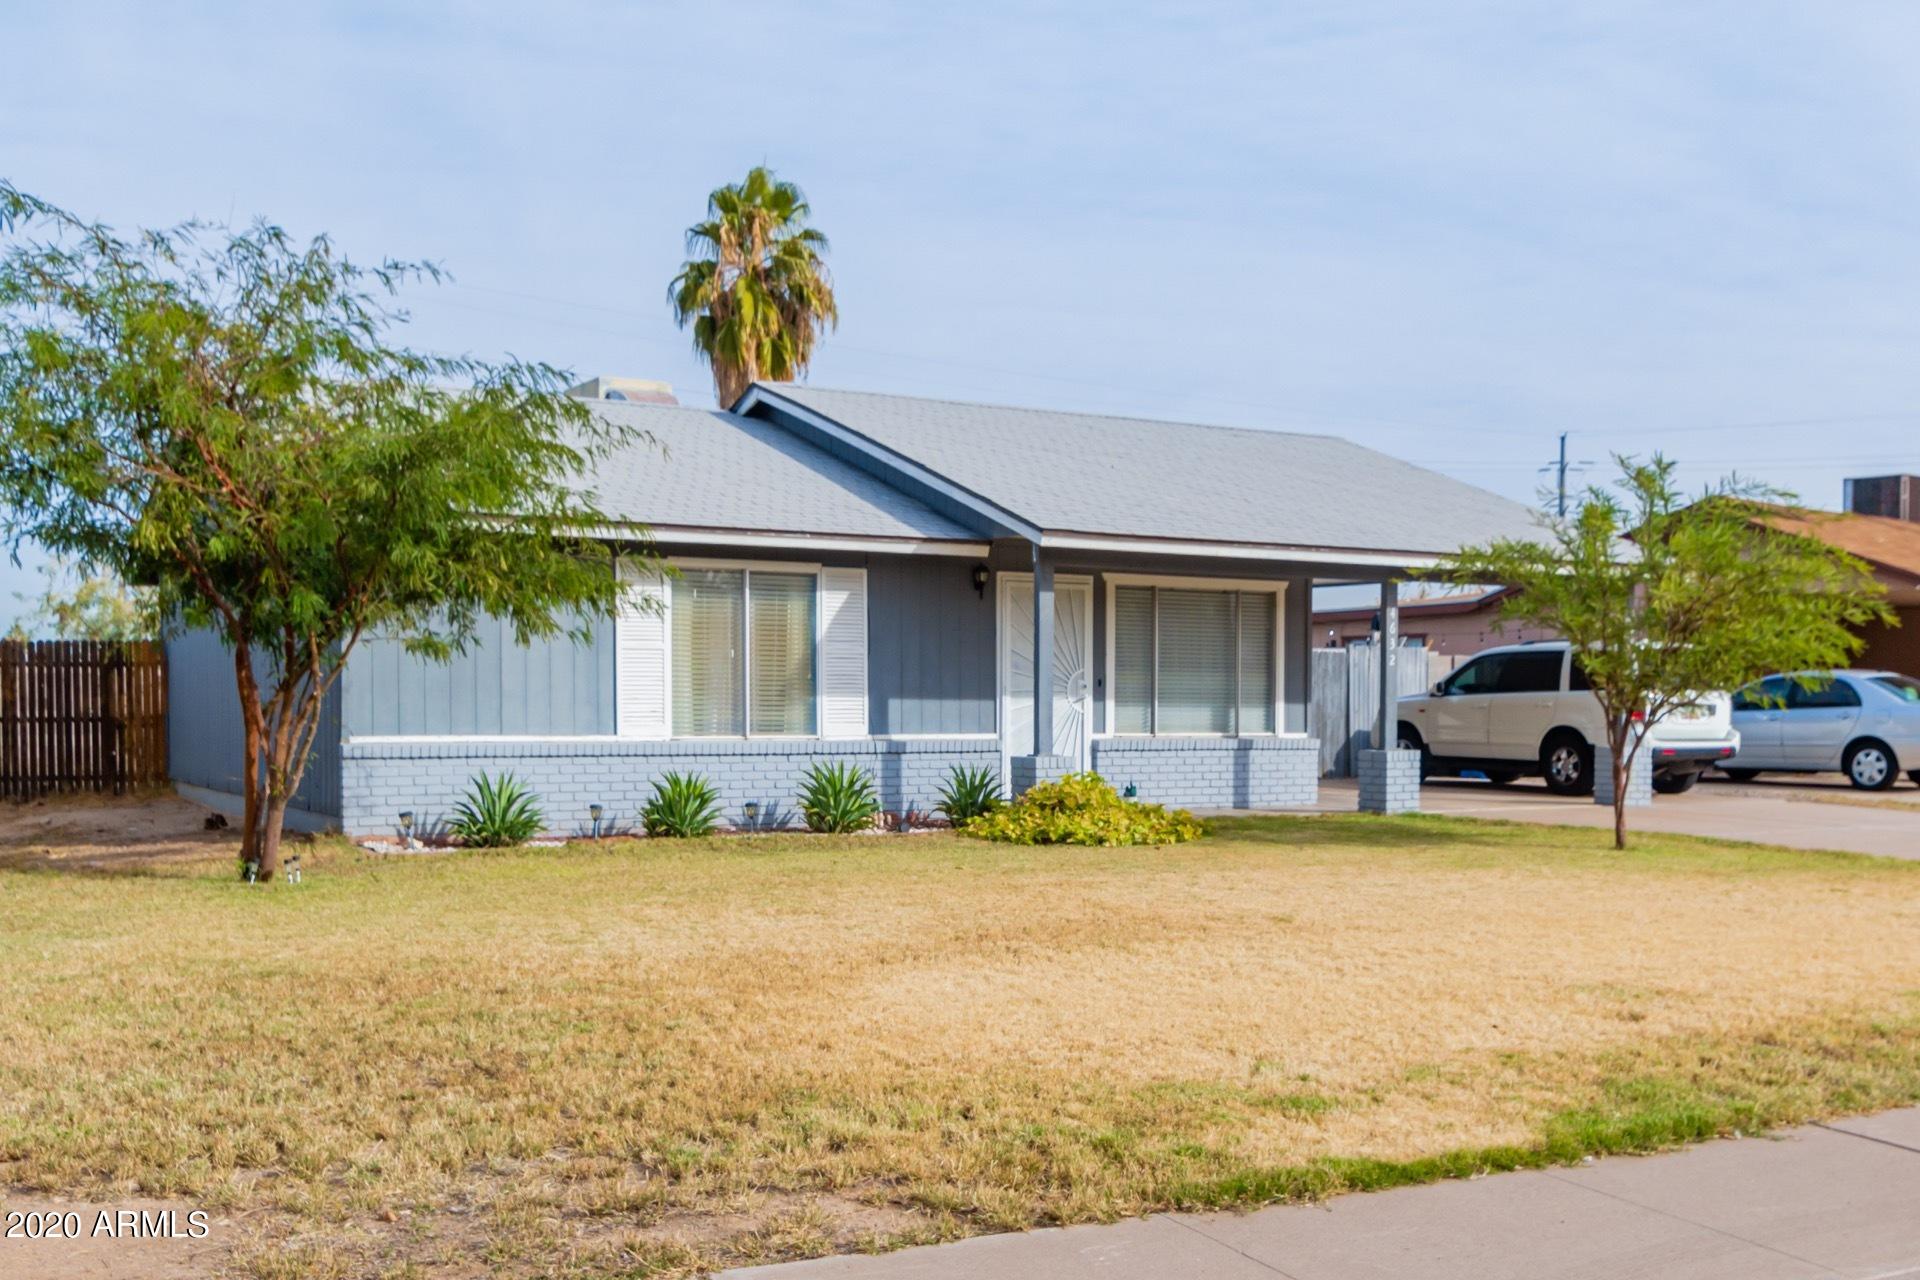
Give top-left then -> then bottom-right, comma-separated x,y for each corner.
0,0 -> 1920,616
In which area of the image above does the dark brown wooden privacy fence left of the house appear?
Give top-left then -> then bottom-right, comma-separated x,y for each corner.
0,641 -> 167,800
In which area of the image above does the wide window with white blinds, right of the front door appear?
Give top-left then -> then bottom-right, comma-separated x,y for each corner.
1112,585 -> 1279,735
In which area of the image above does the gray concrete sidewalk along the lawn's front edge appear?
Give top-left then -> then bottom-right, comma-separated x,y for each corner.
726,1109 -> 1920,1280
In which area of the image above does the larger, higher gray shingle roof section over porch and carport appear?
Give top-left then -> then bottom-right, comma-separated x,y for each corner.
760,384 -> 1536,553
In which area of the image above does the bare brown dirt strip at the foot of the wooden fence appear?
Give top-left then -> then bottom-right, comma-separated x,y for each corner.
0,794 -> 240,871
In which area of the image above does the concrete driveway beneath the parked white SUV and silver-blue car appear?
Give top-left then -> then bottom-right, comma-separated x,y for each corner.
1319,775 -> 1920,858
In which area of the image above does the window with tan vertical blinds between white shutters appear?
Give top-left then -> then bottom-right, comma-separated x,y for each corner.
670,568 -> 818,737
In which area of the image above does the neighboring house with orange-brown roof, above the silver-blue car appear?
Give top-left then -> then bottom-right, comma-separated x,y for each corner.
1776,476 -> 1920,677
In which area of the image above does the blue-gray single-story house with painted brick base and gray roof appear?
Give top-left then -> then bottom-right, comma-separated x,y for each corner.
169,384 -> 1532,833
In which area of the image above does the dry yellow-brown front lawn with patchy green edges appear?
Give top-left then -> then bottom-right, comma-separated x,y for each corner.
0,805 -> 1920,1278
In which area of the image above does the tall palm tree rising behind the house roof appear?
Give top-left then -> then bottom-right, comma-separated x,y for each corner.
666,165 -> 839,409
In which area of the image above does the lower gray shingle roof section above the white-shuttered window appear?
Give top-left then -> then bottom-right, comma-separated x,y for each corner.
582,401 -> 979,541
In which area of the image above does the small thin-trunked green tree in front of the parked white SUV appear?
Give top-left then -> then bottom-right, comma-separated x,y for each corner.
1432,455 -> 1893,848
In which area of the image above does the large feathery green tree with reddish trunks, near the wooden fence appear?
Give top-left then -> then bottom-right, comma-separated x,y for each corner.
0,182 -> 647,877
